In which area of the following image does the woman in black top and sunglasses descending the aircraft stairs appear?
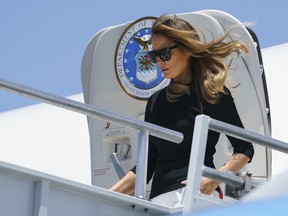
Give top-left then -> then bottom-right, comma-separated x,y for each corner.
111,16 -> 254,206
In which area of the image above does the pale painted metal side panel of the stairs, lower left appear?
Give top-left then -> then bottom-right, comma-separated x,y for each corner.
0,162 -> 179,216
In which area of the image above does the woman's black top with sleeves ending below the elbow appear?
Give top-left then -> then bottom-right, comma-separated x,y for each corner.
131,87 -> 254,198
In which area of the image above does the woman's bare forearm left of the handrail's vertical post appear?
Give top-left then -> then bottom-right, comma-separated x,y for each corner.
109,171 -> 136,195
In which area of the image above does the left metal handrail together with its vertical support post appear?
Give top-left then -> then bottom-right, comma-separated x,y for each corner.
0,79 -> 183,199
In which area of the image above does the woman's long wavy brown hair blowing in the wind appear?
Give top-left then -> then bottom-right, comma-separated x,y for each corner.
152,15 -> 249,103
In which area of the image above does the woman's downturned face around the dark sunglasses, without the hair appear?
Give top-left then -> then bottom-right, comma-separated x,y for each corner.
152,34 -> 191,84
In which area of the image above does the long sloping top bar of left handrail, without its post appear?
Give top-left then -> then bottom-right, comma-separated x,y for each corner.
0,79 -> 183,143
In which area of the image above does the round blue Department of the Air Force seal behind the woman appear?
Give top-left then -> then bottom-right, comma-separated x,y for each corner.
115,17 -> 170,100
